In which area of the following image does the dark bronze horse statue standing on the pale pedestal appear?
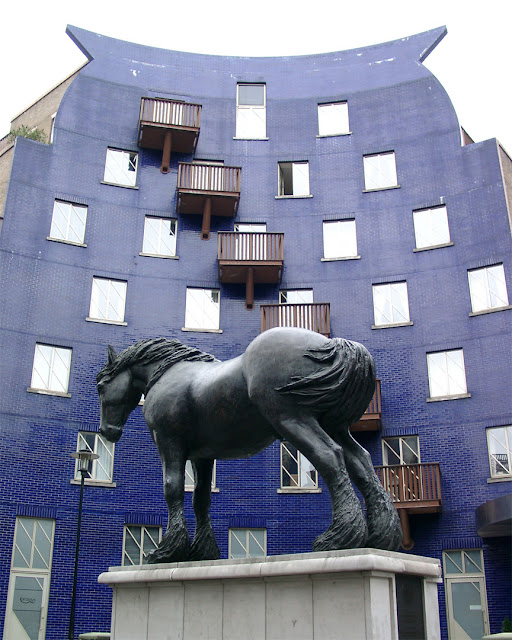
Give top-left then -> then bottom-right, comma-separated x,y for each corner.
97,328 -> 402,563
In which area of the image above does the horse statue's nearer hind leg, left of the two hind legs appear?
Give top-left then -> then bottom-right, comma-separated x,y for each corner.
273,416 -> 367,551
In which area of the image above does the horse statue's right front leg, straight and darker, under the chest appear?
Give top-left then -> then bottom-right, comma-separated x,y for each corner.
190,460 -> 220,560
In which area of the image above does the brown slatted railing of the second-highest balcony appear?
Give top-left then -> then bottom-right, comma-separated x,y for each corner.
178,162 -> 242,194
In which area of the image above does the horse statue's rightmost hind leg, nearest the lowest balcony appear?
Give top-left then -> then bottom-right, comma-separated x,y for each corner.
336,429 -> 402,551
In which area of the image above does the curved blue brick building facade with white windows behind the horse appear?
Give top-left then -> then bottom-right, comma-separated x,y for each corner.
0,27 -> 512,640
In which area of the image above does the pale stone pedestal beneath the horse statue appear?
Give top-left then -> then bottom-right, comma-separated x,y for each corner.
99,549 -> 441,640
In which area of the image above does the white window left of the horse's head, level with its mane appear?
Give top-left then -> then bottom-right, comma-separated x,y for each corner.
30,343 -> 71,394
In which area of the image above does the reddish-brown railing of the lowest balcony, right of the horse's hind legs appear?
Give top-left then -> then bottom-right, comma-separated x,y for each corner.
375,462 -> 441,504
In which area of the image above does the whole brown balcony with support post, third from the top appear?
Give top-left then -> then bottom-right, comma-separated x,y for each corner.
218,232 -> 284,309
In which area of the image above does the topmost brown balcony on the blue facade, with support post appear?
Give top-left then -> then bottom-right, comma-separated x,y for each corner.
137,98 -> 201,173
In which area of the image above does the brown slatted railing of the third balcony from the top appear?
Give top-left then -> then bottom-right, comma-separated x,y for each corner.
218,231 -> 284,262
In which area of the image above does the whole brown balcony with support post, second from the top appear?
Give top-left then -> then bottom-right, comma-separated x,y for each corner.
176,162 -> 242,240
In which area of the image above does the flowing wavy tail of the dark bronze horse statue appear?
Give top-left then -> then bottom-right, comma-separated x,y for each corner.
277,338 -> 375,427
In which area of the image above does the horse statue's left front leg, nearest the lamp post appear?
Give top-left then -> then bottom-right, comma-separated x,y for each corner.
147,440 -> 190,564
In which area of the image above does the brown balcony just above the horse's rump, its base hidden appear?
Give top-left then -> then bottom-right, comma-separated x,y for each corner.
261,302 -> 331,338
